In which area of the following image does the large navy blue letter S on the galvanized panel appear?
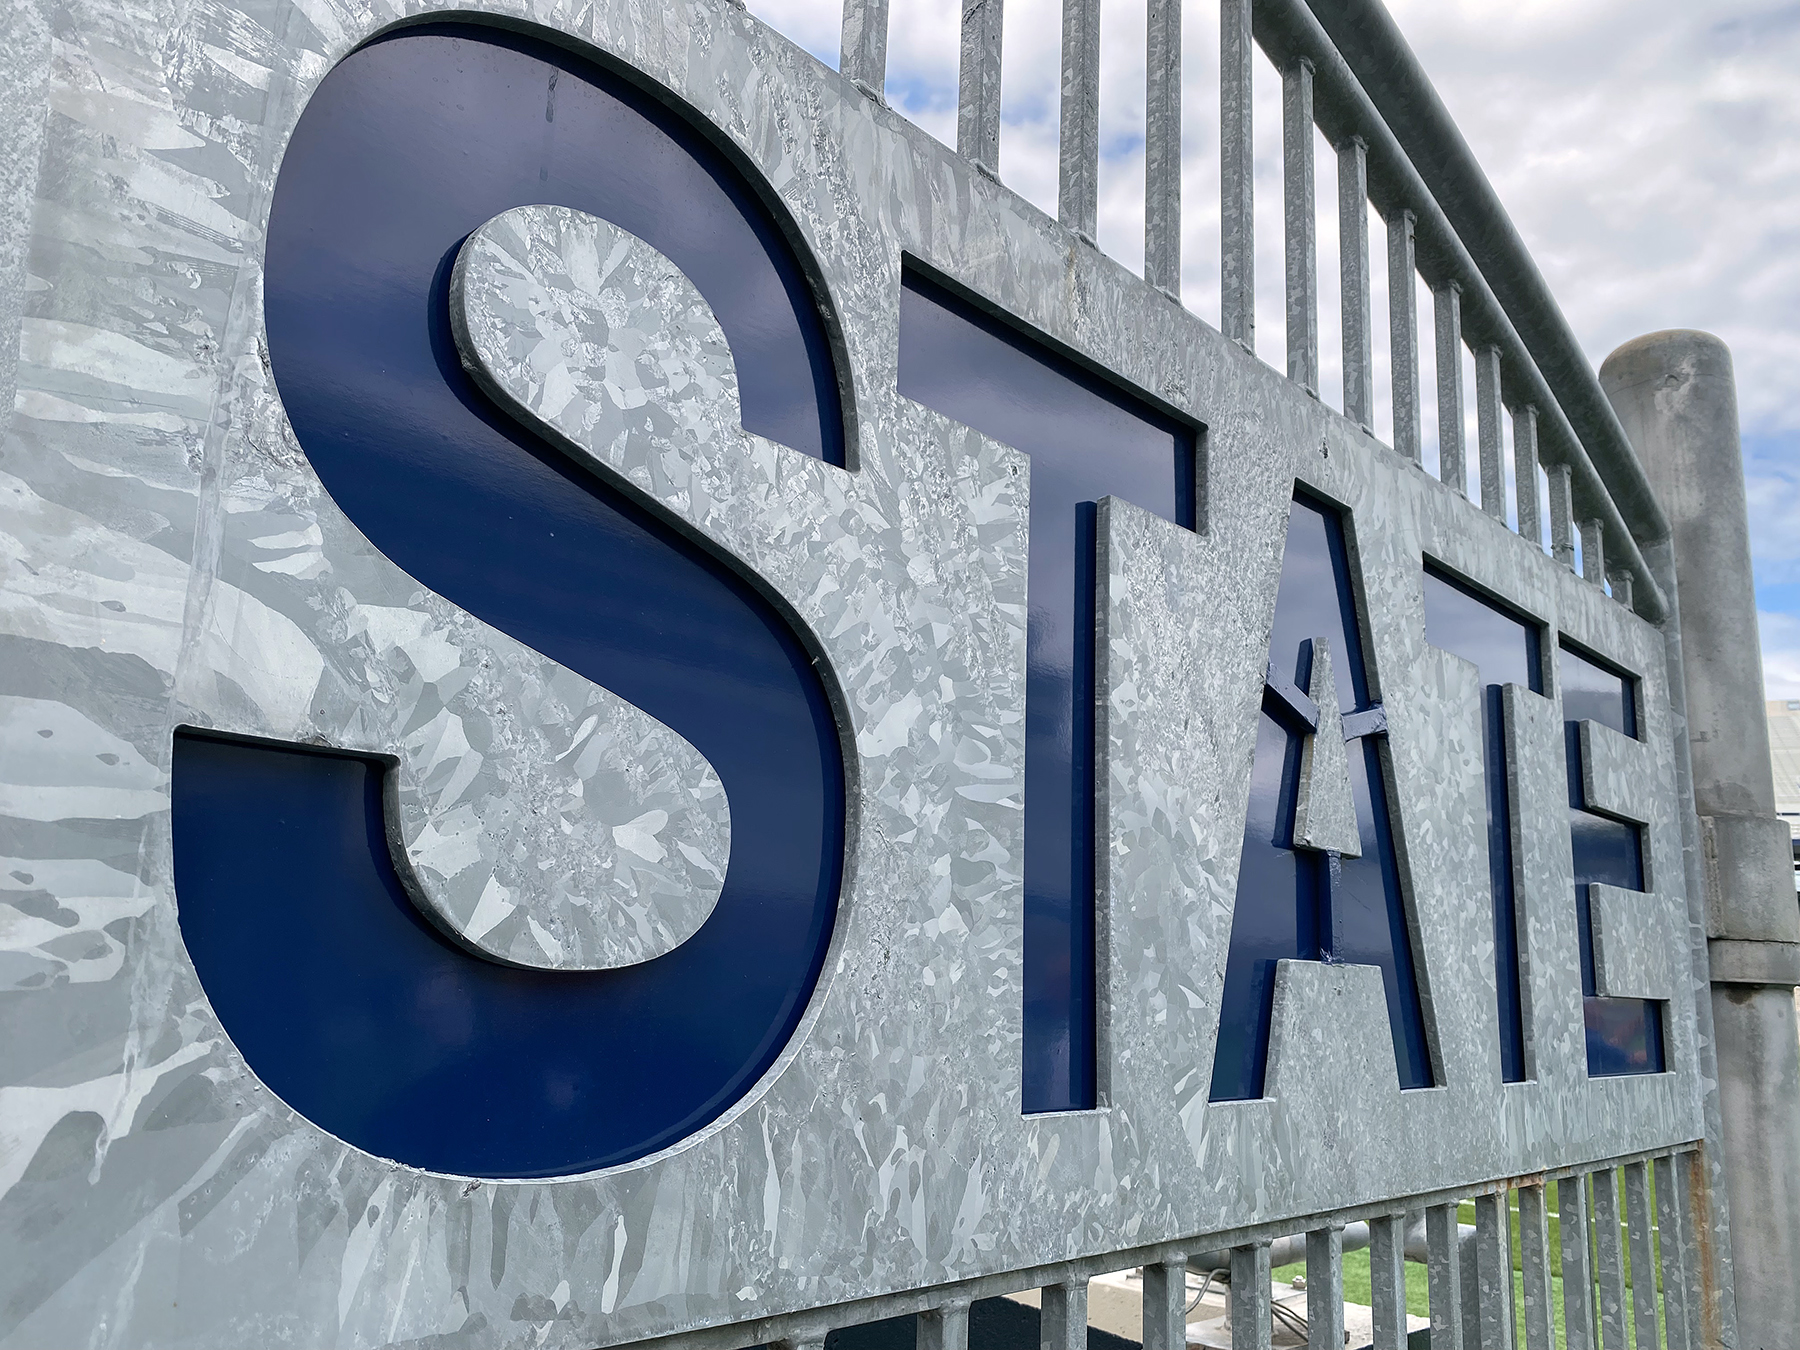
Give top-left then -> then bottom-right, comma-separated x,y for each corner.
175,27 -> 844,1177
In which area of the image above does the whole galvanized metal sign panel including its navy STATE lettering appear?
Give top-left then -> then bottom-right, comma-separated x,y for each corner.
0,0 -> 1701,1348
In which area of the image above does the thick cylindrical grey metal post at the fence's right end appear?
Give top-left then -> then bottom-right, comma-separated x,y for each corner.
1600,331 -> 1800,1350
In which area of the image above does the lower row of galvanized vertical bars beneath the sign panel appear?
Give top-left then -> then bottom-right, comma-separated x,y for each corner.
741,1148 -> 1715,1350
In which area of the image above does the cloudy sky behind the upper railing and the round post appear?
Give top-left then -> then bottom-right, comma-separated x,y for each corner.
749,0 -> 1800,698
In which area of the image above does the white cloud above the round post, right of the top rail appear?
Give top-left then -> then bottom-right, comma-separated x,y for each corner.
1391,0 -> 1800,434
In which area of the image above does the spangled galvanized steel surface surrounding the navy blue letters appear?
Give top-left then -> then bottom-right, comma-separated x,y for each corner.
0,0 -> 1701,1350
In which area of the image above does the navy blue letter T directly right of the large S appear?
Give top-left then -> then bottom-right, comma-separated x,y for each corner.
900,270 -> 1197,1111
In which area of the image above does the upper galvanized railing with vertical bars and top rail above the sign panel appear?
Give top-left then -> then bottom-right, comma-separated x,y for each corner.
839,0 -> 1669,623
